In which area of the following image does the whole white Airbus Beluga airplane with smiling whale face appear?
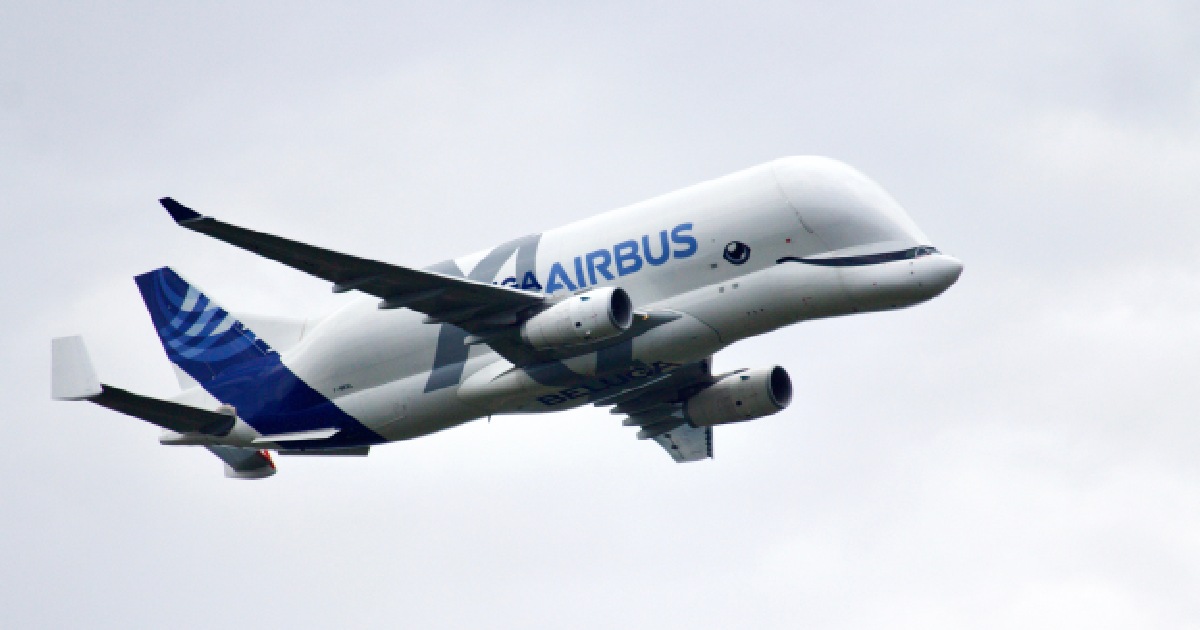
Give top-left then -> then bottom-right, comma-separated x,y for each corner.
52,156 -> 962,479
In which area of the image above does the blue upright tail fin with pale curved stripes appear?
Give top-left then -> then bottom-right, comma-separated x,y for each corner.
134,266 -> 275,385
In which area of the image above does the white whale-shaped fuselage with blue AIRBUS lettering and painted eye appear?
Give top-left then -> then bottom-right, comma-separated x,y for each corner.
169,157 -> 961,443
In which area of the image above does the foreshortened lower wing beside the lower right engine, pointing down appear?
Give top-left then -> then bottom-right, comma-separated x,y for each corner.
595,360 -> 715,463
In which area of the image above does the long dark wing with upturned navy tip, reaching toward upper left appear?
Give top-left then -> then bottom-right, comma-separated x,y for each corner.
160,197 -> 545,334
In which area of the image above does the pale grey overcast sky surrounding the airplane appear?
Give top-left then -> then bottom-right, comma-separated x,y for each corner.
0,0 -> 1200,629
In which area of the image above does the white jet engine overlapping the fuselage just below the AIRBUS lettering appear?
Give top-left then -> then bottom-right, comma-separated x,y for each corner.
521,287 -> 634,350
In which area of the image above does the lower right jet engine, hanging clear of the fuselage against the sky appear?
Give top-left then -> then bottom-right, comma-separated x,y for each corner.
684,366 -> 792,426
